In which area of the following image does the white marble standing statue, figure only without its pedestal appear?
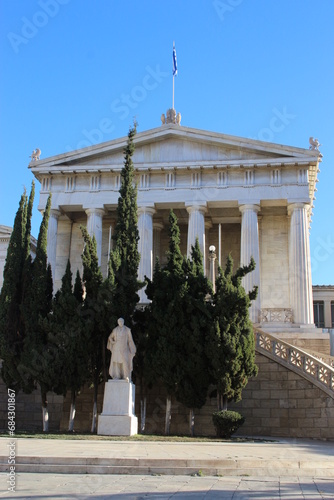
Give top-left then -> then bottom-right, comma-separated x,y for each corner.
107,318 -> 136,382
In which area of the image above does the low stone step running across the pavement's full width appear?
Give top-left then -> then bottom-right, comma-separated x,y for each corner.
0,456 -> 334,478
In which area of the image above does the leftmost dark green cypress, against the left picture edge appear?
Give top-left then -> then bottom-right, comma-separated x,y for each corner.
0,182 -> 35,391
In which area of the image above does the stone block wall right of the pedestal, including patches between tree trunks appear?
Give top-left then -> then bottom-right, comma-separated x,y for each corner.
132,354 -> 334,439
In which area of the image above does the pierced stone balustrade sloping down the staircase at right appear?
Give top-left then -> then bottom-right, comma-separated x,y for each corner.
254,328 -> 334,399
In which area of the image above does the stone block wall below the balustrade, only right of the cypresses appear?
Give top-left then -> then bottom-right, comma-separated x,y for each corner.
231,354 -> 334,439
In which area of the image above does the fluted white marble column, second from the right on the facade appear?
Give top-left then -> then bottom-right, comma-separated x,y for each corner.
239,204 -> 261,323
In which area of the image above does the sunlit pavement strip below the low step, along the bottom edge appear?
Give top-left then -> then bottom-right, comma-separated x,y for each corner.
0,473 -> 334,500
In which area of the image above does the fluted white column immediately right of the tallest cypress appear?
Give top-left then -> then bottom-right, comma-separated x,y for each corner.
138,207 -> 155,304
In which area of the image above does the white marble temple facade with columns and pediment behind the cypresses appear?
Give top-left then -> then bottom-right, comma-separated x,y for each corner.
29,119 -> 321,327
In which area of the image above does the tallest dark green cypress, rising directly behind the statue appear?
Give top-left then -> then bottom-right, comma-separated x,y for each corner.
109,123 -> 143,327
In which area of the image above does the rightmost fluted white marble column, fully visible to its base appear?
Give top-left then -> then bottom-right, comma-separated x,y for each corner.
288,203 -> 314,325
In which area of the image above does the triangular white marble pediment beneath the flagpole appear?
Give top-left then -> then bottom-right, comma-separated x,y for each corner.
29,124 -> 319,173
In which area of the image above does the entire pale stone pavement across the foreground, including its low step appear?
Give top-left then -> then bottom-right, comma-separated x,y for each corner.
0,438 -> 334,500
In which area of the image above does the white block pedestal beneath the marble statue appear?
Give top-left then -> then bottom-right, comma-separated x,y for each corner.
97,380 -> 138,436
